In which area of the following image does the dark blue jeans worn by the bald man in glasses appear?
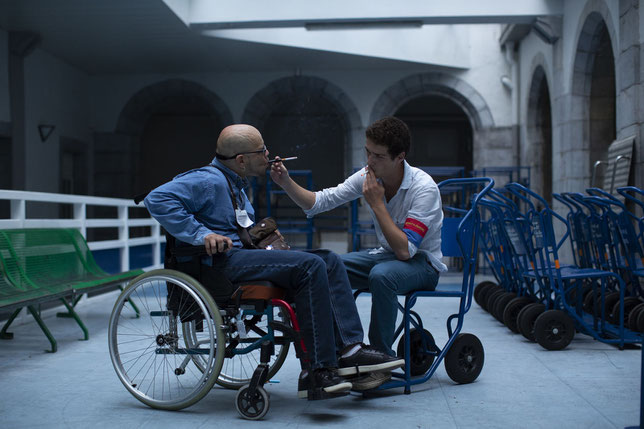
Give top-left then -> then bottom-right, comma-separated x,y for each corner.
215,248 -> 364,369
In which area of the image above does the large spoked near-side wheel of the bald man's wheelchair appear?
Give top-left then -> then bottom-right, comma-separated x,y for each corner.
108,270 -> 225,410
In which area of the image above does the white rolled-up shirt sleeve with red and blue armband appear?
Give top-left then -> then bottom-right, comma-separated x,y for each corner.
403,182 -> 443,257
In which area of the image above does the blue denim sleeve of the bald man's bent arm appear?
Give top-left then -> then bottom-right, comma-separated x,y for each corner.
144,176 -> 215,246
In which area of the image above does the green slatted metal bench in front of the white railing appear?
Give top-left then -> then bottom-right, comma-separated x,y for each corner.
0,228 -> 143,352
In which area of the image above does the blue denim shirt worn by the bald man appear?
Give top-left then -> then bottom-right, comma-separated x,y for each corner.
144,158 -> 255,247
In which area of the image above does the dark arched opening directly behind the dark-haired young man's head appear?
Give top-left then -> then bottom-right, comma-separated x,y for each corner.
394,95 -> 472,176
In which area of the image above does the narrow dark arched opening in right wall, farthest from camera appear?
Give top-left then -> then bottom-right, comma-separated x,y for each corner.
521,66 -> 552,203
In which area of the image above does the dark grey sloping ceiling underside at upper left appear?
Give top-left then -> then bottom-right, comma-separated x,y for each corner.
0,0 -> 448,75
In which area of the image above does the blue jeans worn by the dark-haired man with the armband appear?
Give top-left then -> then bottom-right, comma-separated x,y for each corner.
341,250 -> 439,356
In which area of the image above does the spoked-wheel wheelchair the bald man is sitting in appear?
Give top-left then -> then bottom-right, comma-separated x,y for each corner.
108,236 -> 308,420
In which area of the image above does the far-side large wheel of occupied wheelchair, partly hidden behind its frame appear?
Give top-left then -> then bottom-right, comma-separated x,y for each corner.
189,307 -> 290,390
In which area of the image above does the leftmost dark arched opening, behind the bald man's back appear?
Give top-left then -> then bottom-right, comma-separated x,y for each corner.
107,79 -> 232,198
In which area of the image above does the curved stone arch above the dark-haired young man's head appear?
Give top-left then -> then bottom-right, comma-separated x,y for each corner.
370,72 -> 494,130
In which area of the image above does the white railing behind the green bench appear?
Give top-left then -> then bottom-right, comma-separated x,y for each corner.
0,190 -> 165,271
